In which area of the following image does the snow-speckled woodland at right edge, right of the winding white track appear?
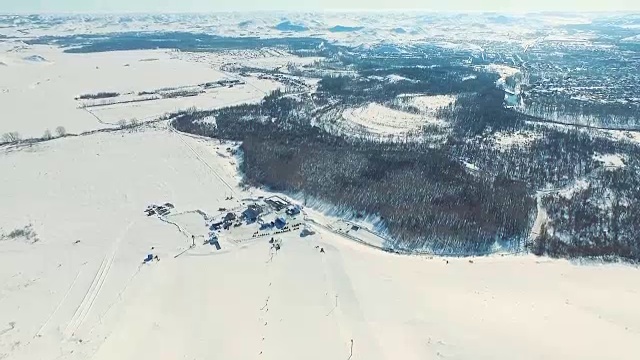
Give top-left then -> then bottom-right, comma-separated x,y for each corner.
532,162 -> 640,261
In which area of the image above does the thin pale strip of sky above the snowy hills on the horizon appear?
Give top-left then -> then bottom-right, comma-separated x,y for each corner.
0,0 -> 640,13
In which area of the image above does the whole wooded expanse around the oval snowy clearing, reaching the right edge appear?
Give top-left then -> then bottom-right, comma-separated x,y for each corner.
168,42 -> 640,261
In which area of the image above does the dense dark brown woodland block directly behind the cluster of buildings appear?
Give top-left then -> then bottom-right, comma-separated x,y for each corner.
173,83 -> 535,254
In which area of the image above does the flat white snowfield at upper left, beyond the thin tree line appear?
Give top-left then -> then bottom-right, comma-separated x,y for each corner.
0,43 -> 280,138
